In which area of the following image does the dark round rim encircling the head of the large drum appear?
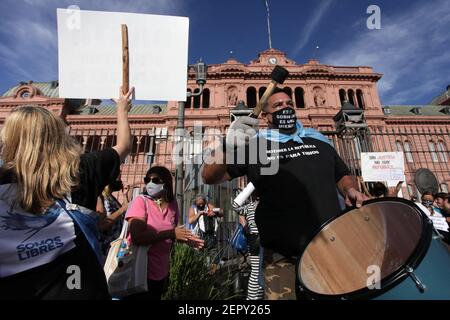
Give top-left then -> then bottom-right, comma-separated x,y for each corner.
295,197 -> 433,300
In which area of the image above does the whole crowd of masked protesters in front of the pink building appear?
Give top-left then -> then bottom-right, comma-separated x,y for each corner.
0,85 -> 450,300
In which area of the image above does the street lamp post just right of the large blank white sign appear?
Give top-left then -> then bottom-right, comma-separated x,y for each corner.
175,60 -> 207,222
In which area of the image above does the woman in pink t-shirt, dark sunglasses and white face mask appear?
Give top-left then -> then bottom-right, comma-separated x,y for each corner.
124,166 -> 203,300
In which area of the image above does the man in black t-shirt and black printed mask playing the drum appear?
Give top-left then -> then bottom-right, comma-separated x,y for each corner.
202,89 -> 367,299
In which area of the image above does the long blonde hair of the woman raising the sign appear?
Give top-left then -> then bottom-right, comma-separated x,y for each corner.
1,106 -> 81,214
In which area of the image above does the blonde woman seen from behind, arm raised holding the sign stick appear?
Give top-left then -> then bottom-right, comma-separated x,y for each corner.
0,86 -> 132,300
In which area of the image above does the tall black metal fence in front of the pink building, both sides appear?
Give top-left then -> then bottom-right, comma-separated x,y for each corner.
67,126 -> 450,222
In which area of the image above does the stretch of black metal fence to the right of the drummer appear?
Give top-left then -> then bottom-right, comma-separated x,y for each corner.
325,126 -> 450,198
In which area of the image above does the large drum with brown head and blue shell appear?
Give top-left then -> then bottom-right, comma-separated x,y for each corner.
297,198 -> 450,299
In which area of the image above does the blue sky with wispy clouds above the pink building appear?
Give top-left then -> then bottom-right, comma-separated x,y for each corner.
0,0 -> 450,104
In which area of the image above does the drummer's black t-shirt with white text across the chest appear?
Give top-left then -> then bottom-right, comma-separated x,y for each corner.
227,138 -> 349,256
